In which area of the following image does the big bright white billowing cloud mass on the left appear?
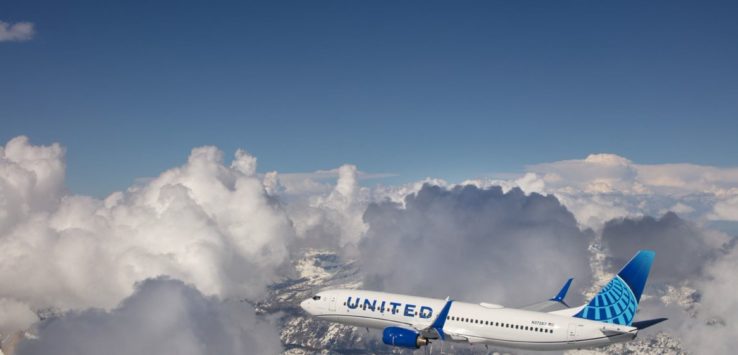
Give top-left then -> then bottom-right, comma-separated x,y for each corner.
0,137 -> 294,336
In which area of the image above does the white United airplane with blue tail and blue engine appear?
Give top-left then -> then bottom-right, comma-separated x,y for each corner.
300,250 -> 666,352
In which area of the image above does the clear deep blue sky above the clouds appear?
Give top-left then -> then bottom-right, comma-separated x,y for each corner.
0,1 -> 738,196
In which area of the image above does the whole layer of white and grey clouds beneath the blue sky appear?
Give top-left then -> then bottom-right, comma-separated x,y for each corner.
0,137 -> 738,354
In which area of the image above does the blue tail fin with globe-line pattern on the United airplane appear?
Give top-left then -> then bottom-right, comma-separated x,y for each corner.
574,250 -> 656,325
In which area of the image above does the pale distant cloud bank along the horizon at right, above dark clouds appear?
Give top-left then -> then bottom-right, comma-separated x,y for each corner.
448,154 -> 738,229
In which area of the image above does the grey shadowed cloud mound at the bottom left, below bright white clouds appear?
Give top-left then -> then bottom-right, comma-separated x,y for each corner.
17,278 -> 281,355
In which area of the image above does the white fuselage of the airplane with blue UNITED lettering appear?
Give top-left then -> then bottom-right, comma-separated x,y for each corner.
301,290 -> 637,350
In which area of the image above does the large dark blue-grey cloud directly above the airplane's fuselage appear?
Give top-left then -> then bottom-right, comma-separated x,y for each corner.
359,185 -> 592,305
